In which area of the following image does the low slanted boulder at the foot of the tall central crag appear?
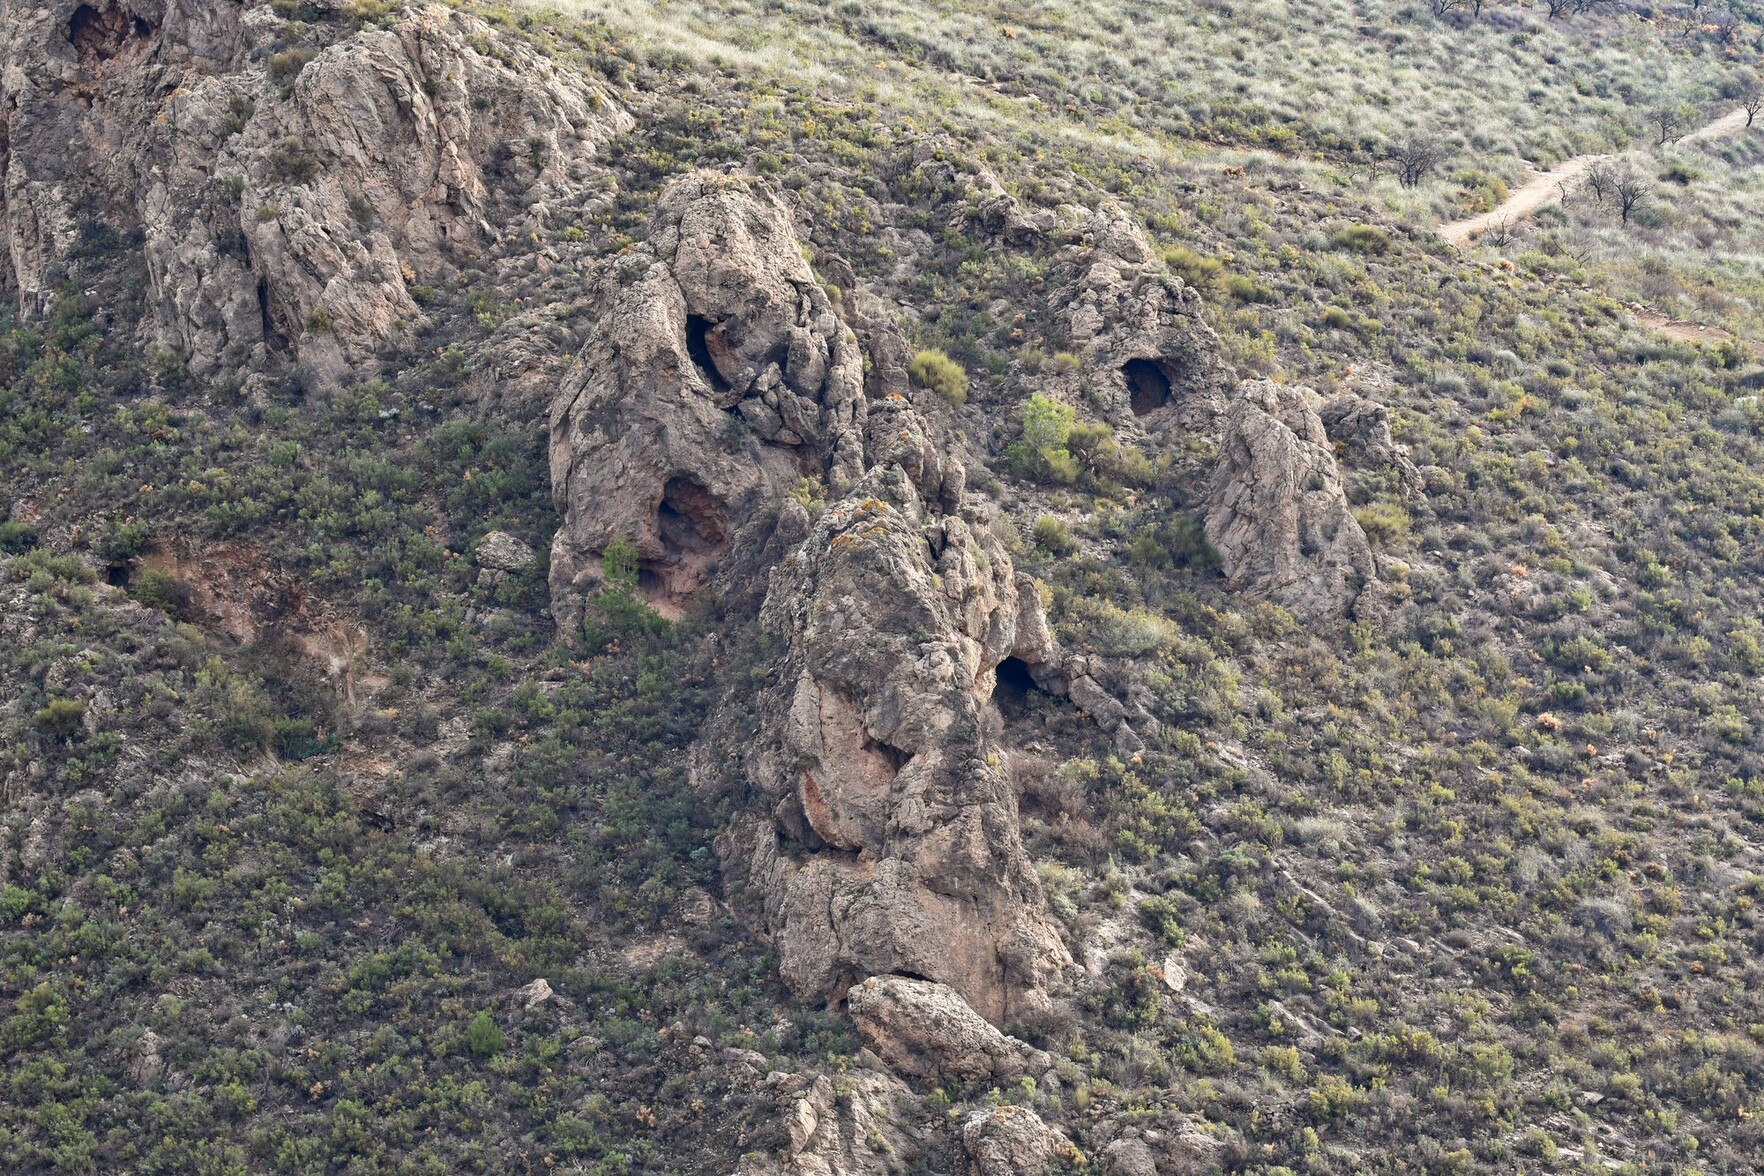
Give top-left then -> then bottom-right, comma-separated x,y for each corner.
845,977 -> 1053,1083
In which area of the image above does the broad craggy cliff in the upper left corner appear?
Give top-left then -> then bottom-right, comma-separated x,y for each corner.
0,0 -> 630,379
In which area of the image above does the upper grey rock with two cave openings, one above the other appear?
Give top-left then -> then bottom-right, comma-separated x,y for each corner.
550,175 -> 864,631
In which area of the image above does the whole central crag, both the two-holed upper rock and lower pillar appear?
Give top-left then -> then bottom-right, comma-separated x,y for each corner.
550,175 -> 1069,1019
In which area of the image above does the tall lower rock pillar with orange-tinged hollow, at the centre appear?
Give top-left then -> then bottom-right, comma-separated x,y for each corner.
721,465 -> 1069,1021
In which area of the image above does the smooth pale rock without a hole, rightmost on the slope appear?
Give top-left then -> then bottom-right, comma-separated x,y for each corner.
1207,381 -> 1376,617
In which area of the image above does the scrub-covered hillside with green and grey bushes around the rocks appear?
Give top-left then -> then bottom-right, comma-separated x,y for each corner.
0,5 -> 1764,1171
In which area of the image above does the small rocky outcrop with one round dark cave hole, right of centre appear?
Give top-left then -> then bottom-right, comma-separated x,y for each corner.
1060,210 -> 1237,432
